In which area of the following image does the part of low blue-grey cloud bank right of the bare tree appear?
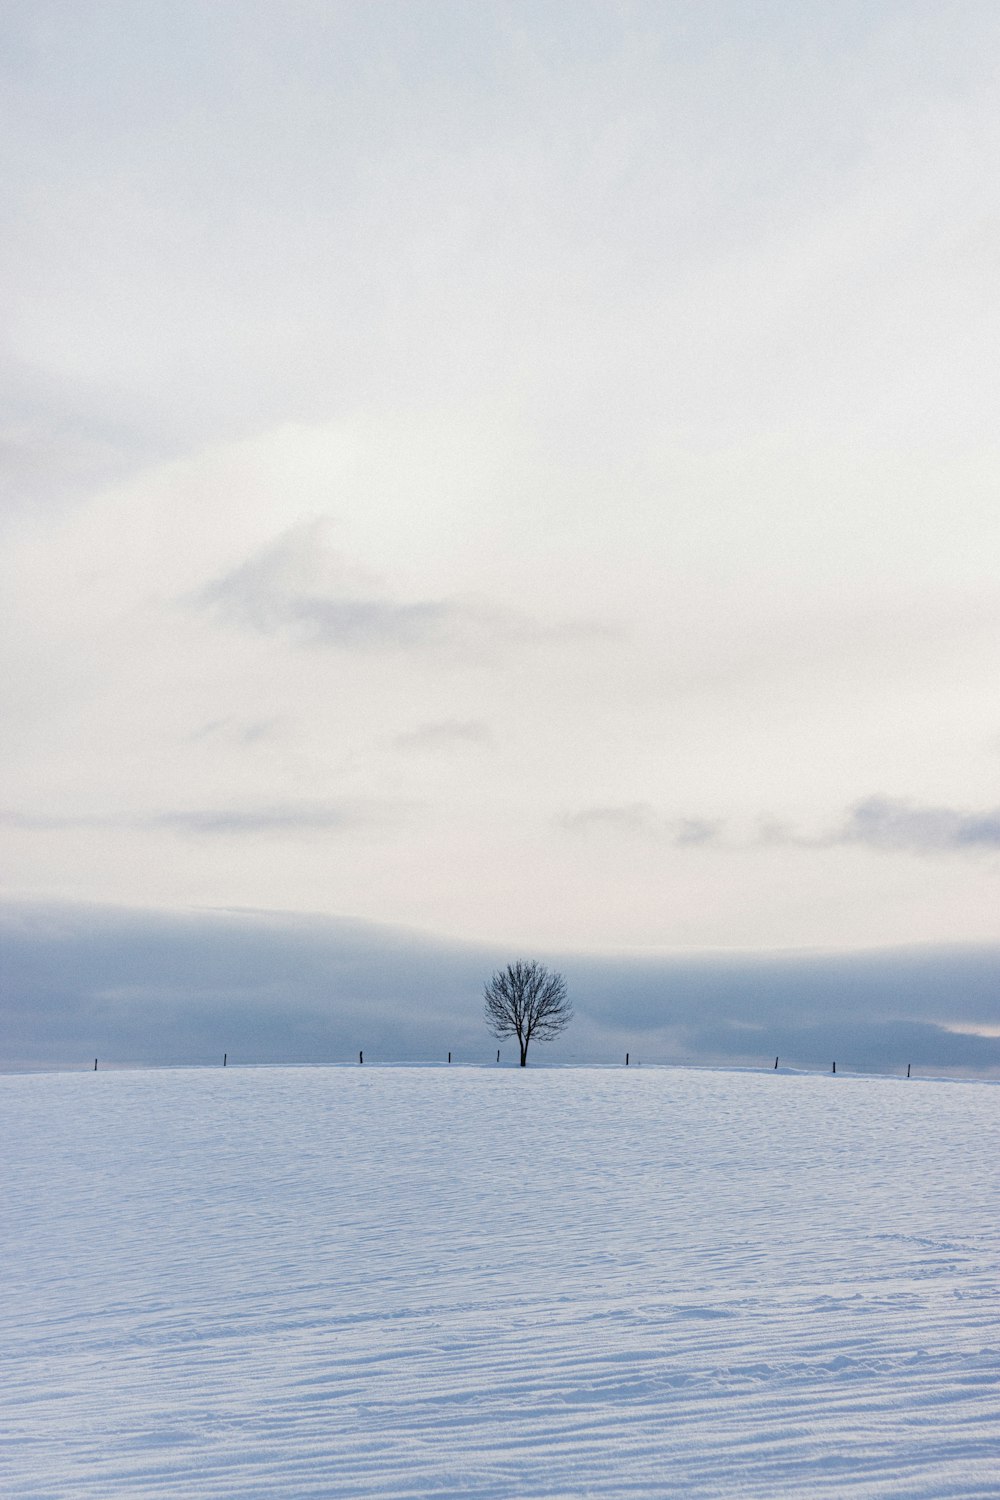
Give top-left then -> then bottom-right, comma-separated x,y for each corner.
558,947 -> 1000,1071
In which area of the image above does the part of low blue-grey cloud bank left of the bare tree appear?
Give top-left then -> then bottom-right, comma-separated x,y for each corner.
0,903 -> 493,1067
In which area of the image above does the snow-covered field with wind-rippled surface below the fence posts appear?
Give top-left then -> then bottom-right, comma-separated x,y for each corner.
0,1067 -> 1000,1500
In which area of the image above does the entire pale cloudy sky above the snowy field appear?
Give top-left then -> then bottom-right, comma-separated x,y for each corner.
0,0 -> 1000,1067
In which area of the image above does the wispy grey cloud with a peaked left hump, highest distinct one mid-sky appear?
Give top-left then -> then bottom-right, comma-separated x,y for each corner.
193,518 -> 609,656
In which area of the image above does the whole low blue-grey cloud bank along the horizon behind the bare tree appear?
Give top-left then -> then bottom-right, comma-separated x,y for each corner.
0,905 -> 1000,1074
